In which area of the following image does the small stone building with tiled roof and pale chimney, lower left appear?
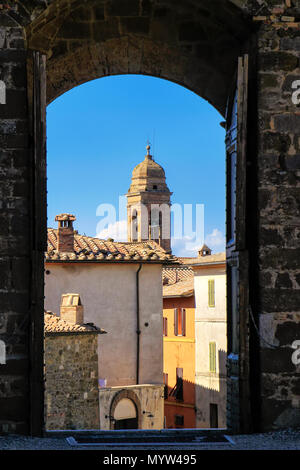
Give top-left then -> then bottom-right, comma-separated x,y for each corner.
44,294 -> 106,430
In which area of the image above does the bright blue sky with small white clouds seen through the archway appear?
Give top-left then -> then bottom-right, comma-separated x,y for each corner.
47,75 -> 225,256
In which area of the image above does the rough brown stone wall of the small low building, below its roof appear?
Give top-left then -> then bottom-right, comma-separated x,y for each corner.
45,332 -> 99,430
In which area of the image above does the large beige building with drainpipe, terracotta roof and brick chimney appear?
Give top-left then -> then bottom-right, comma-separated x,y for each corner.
45,214 -> 176,429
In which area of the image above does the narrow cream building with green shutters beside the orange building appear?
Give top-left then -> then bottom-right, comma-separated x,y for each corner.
185,250 -> 227,428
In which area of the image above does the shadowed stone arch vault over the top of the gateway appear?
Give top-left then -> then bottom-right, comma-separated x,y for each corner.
27,0 -> 252,436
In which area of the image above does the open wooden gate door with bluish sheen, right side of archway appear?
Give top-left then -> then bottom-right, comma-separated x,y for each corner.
226,55 -> 251,432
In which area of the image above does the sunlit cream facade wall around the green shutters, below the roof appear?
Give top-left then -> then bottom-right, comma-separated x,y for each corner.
194,266 -> 227,428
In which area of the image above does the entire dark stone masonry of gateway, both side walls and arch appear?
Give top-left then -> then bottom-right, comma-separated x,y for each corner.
0,0 -> 300,435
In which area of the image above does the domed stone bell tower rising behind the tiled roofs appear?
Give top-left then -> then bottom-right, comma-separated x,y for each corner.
126,145 -> 172,252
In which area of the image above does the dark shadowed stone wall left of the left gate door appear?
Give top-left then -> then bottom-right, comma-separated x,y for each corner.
0,10 -> 31,433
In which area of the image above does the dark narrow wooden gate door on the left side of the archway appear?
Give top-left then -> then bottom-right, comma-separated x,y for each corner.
28,51 -> 47,436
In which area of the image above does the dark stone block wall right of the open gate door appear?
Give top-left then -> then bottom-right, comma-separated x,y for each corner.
258,19 -> 300,428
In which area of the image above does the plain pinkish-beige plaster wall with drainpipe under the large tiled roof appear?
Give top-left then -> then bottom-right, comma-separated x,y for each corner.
45,263 -> 163,386
